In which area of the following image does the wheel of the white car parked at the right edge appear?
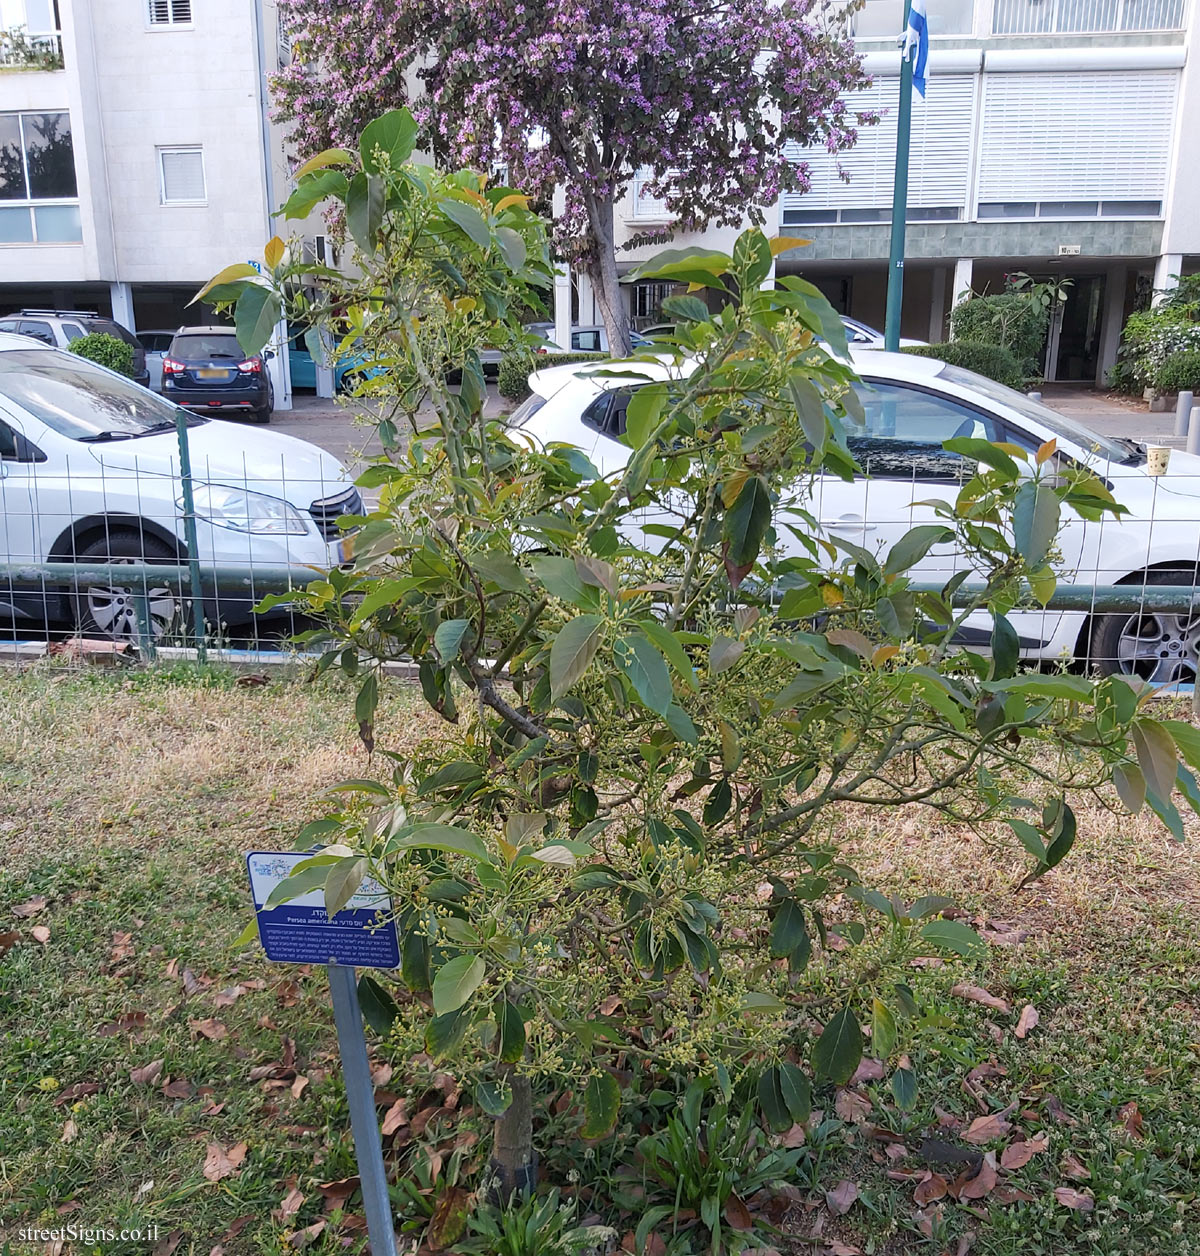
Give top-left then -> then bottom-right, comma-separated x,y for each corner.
1091,570 -> 1200,685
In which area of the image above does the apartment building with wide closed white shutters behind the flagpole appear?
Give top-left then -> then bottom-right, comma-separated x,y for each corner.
623,0 -> 1200,384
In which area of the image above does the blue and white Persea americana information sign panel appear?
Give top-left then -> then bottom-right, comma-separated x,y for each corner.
246,850 -> 400,968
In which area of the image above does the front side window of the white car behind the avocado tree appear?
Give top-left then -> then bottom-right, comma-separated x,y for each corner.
846,379 -> 999,481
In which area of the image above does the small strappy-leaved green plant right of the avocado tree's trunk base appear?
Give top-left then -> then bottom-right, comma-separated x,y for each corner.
631,1079 -> 805,1256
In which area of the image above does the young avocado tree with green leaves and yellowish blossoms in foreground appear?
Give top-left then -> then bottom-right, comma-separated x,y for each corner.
211,108 -> 1200,1225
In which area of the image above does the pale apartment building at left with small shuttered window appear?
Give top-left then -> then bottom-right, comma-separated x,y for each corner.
0,0 -> 295,404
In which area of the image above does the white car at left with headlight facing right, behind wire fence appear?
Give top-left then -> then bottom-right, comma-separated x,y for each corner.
0,334 -> 362,638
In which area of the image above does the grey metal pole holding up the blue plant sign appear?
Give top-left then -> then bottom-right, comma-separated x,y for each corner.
325,963 -> 396,1256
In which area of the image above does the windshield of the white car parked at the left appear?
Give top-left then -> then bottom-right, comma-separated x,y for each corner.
0,349 -> 203,441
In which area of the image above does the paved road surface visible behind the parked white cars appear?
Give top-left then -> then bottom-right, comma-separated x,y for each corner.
271,384 -> 1184,467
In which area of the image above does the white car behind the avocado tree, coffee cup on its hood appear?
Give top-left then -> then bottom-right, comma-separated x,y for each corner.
510,349 -> 1200,685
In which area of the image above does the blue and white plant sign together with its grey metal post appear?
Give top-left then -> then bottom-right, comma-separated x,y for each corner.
246,850 -> 400,1256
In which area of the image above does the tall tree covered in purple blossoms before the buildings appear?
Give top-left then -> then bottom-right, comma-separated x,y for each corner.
274,0 -> 866,352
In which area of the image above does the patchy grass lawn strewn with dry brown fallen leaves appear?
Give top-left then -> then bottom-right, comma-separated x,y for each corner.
0,666 -> 1200,1256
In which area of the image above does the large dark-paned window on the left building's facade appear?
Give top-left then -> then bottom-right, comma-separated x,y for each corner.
0,113 -> 83,244
